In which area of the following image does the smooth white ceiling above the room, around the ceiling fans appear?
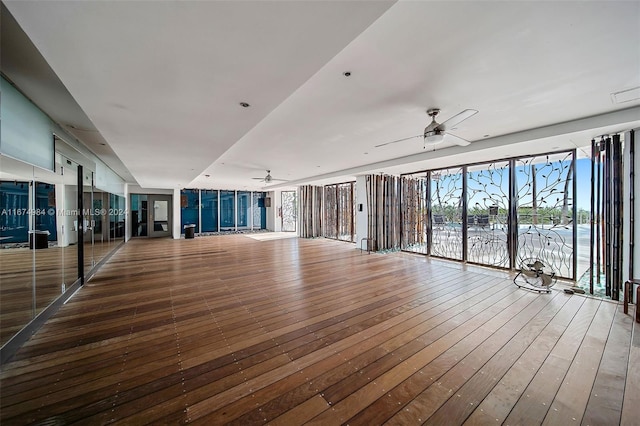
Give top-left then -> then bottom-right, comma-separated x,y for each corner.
2,1 -> 640,189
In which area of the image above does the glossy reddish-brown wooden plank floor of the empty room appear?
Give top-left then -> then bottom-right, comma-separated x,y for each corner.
0,235 -> 640,425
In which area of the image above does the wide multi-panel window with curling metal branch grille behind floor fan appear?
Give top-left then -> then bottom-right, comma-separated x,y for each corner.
400,151 -> 576,279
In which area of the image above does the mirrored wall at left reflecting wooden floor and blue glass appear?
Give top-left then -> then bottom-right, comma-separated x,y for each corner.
0,153 -> 124,345
